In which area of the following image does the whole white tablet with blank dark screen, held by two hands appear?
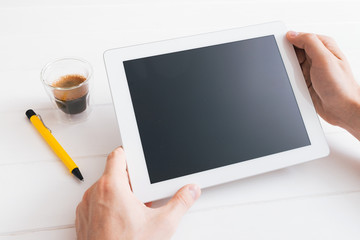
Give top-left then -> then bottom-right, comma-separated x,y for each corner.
104,22 -> 329,202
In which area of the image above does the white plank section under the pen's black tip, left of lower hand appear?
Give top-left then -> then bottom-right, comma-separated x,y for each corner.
0,157 -> 106,235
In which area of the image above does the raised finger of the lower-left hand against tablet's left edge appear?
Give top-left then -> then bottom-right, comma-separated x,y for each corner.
104,147 -> 128,179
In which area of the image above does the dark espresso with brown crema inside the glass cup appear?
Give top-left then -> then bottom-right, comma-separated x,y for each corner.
52,74 -> 89,114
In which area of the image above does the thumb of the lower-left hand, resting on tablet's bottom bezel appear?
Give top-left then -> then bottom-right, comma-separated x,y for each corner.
162,184 -> 201,224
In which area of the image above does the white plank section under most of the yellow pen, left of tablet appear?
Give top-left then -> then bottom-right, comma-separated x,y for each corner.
0,104 -> 122,166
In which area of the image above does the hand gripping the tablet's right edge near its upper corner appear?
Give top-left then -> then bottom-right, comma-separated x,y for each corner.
286,31 -> 360,140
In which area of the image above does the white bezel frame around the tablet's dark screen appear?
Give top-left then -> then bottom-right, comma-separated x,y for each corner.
104,22 -> 329,202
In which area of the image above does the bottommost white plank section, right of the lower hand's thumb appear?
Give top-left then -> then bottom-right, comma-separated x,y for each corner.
173,192 -> 360,240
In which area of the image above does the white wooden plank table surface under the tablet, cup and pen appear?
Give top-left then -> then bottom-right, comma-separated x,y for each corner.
0,0 -> 360,240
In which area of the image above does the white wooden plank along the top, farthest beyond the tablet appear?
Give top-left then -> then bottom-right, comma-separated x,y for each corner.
0,1 -> 359,37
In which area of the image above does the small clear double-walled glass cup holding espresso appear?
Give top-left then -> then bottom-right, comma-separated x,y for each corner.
41,58 -> 93,123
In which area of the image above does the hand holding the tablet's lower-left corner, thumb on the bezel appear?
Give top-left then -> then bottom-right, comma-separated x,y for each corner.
75,147 -> 201,240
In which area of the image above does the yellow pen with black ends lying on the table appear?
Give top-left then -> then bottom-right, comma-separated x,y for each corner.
25,109 -> 84,181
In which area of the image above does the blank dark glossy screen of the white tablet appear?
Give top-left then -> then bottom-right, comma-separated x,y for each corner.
124,35 -> 310,183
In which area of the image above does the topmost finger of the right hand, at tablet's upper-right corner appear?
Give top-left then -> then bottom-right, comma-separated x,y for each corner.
286,31 -> 332,63
